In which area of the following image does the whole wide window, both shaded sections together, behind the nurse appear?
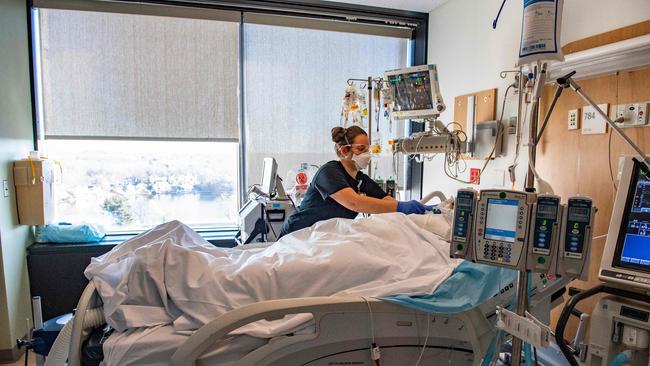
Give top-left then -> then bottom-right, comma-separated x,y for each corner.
32,0 -> 426,232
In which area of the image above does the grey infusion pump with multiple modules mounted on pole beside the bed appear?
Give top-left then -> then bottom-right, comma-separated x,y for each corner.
449,189 -> 595,278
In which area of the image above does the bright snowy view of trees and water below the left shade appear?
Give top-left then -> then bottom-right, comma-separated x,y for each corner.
46,140 -> 238,232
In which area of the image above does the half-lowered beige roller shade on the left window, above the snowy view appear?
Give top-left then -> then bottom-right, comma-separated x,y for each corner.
35,7 -> 239,141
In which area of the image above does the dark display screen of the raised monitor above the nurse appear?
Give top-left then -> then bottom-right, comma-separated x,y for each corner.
388,70 -> 433,111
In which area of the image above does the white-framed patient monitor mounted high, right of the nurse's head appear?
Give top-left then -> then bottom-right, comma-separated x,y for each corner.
384,65 -> 445,119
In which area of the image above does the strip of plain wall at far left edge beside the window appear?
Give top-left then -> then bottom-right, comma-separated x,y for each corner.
0,0 -> 33,350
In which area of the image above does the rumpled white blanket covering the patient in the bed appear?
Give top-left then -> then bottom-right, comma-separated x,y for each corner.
85,214 -> 458,337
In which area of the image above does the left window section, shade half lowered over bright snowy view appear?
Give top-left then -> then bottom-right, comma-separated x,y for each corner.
37,5 -> 239,232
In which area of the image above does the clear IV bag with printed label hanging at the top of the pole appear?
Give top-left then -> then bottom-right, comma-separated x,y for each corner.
517,0 -> 564,66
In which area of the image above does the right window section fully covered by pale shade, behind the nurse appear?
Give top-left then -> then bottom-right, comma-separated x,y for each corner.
243,20 -> 409,189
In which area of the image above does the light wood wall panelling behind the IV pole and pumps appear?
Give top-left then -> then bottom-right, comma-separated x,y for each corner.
537,68 -> 650,334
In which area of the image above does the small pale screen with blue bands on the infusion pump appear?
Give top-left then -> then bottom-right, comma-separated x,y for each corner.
485,198 -> 519,243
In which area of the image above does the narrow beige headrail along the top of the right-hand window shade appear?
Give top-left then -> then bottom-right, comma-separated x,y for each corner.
244,13 -> 413,39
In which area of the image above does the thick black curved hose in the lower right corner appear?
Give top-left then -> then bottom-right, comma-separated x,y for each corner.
555,285 -> 650,366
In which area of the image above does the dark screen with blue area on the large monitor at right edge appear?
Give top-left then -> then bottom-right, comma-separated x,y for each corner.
619,167 -> 650,272
